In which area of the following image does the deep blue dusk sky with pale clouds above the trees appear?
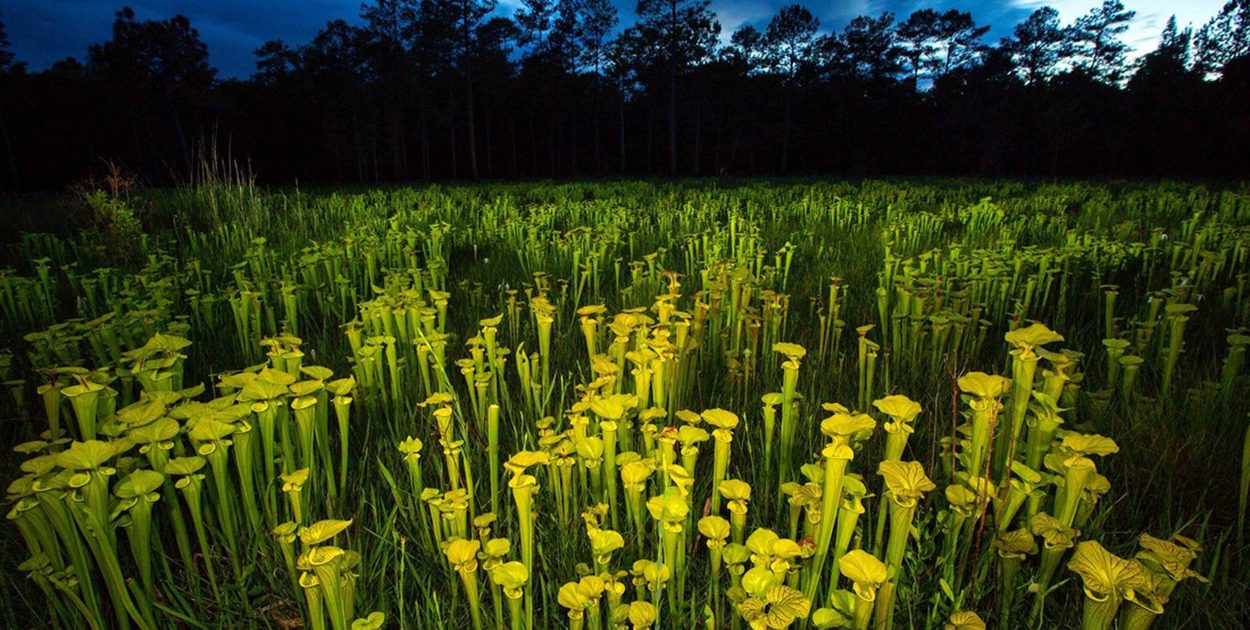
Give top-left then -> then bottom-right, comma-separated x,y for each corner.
0,0 -> 1225,78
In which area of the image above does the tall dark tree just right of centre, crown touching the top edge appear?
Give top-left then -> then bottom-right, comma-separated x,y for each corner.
631,0 -> 720,175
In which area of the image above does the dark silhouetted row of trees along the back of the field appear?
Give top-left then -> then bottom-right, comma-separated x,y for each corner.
0,0 -> 1250,189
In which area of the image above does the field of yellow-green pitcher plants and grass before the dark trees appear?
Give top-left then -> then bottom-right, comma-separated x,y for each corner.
0,180 -> 1250,630
